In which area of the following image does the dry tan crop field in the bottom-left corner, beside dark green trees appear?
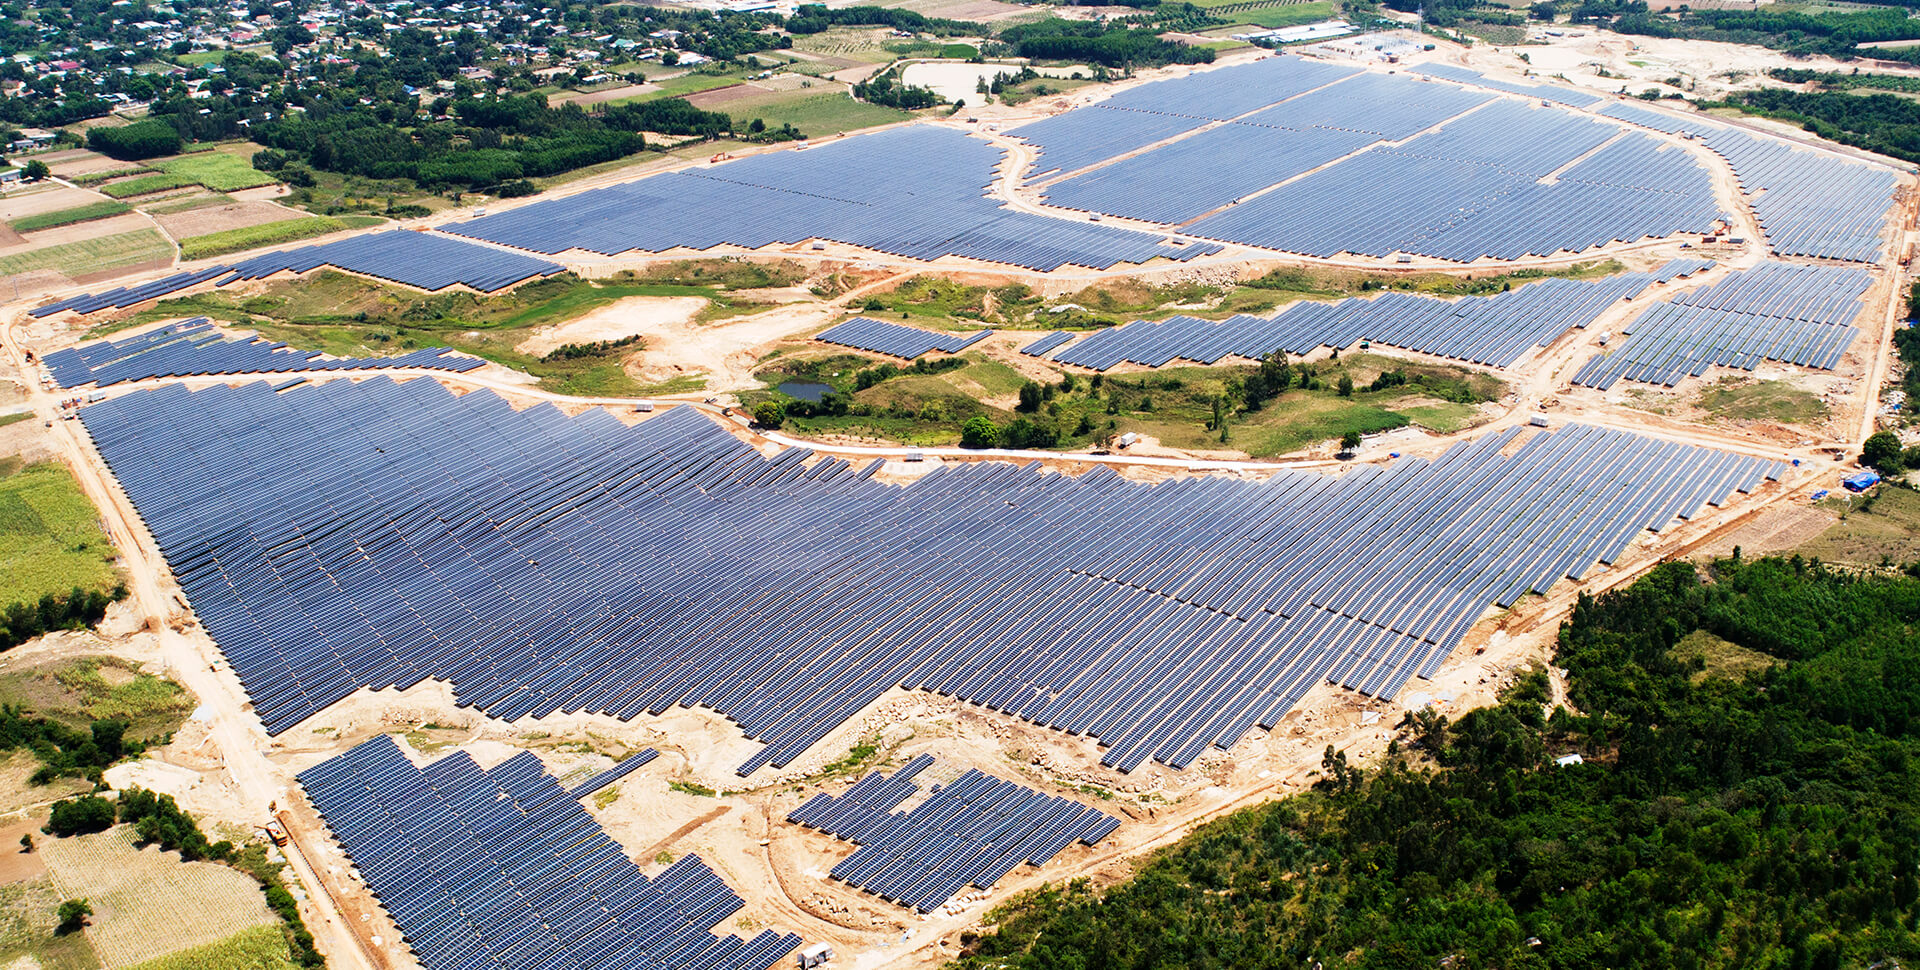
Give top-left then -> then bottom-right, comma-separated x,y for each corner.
40,826 -> 278,970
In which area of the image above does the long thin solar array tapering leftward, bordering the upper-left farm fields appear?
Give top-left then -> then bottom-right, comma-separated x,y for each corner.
29,230 -> 564,317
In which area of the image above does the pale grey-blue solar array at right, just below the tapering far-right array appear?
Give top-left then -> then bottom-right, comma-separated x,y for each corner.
1572,261 -> 1874,388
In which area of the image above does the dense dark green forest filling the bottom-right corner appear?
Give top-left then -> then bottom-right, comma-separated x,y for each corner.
960,549 -> 1920,970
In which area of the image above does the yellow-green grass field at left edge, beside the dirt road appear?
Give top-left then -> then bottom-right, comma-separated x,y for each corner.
0,459 -> 119,605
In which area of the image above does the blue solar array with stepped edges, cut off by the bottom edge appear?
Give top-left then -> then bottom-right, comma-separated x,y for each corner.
300,736 -> 801,970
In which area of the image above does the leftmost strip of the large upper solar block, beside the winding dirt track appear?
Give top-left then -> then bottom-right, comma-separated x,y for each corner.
1008,56 -> 1357,177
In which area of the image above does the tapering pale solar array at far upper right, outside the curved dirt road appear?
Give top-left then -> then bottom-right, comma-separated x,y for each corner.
1601,104 -> 1899,263
